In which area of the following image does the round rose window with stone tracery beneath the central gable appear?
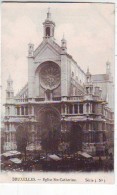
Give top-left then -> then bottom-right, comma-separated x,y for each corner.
40,62 -> 60,90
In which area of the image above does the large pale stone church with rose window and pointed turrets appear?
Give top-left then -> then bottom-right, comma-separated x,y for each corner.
4,11 -> 114,156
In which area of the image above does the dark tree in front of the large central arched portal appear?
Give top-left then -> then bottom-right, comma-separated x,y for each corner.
40,110 -> 60,153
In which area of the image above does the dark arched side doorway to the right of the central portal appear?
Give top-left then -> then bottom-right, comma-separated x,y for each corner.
70,122 -> 83,152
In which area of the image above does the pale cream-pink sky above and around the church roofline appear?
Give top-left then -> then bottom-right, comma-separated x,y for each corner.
1,3 -> 115,101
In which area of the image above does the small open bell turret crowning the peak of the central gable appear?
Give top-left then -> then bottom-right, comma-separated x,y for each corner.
43,8 -> 55,40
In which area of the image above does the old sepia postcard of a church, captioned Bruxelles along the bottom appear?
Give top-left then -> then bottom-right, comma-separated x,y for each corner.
0,2 -> 115,184
